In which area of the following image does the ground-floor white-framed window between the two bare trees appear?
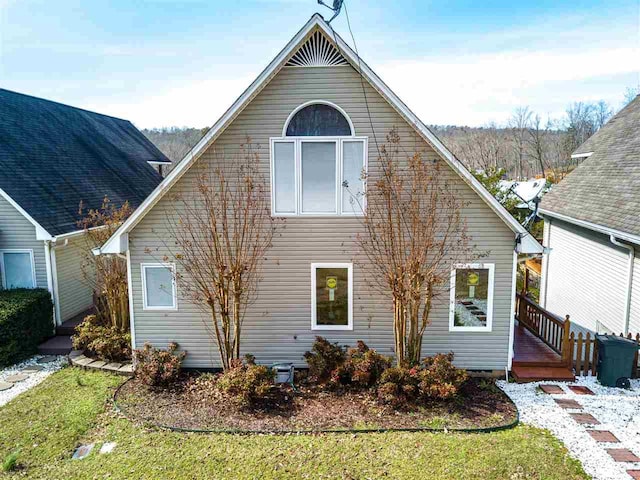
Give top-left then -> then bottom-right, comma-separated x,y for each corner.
311,263 -> 353,330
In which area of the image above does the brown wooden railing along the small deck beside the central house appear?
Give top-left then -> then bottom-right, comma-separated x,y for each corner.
516,293 -> 570,360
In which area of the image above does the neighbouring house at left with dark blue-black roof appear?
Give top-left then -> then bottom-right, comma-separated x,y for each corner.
0,89 -> 169,325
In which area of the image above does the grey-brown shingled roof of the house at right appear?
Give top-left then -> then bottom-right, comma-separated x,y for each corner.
540,96 -> 640,244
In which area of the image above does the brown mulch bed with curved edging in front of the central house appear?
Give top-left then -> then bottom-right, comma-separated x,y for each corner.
116,373 -> 517,432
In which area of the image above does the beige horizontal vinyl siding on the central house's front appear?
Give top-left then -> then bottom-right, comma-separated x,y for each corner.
129,63 -> 514,369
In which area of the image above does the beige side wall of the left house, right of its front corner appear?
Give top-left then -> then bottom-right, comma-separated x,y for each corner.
55,235 -> 93,321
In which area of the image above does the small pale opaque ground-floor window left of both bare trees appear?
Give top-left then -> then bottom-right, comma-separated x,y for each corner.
142,263 -> 178,310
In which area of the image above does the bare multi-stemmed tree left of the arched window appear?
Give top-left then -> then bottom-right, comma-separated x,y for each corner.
162,142 -> 281,370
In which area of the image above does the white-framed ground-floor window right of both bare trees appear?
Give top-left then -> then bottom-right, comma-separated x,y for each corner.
449,263 -> 495,332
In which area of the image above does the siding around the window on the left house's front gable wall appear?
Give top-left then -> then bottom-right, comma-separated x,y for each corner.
0,197 -> 48,288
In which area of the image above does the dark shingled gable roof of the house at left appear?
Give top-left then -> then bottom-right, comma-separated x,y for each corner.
0,89 -> 171,239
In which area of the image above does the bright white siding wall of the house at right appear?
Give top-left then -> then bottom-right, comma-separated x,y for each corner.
543,219 -> 628,333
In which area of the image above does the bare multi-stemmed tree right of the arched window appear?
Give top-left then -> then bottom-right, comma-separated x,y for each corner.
356,130 -> 473,365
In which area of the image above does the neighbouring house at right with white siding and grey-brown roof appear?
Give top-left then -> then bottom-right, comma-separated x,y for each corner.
540,97 -> 640,334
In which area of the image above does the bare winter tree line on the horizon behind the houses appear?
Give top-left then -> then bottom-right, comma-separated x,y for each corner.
142,88 -> 638,182
